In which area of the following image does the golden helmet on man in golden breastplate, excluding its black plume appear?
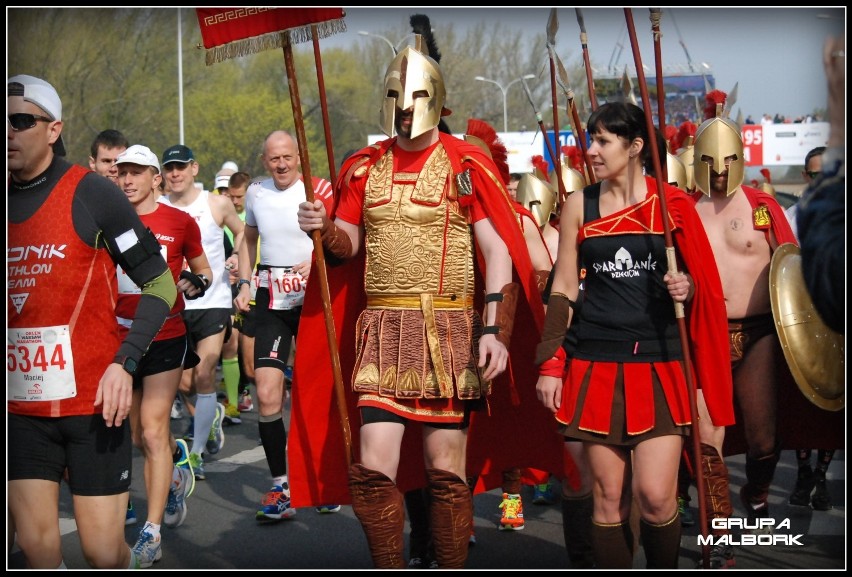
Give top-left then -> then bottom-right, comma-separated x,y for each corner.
379,34 -> 449,138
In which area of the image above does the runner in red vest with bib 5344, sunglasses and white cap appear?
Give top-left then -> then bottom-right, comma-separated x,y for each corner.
6,75 -> 176,569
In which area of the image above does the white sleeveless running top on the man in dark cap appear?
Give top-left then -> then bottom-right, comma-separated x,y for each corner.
159,190 -> 232,310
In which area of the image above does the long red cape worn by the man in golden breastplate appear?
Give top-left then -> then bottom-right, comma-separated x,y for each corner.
288,134 -> 562,507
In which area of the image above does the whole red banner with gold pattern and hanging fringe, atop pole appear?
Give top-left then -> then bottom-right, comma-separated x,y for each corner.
195,8 -> 346,66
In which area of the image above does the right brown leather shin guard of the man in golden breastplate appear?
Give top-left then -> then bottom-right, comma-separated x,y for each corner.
426,469 -> 473,569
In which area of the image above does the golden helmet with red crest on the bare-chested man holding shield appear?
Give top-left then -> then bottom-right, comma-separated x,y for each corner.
693,105 -> 745,196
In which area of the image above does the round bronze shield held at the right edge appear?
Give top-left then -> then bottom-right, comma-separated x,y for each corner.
769,243 -> 846,411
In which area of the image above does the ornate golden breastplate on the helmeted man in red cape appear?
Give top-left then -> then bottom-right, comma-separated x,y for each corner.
364,144 -> 474,297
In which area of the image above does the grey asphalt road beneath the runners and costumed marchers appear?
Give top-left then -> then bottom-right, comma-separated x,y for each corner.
7,400 -> 847,570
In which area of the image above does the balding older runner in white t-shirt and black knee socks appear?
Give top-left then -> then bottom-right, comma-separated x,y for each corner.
234,131 -> 336,521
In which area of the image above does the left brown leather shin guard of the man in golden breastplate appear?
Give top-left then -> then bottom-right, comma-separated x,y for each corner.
349,463 -> 410,569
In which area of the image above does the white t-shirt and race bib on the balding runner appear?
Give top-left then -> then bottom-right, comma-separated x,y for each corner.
246,178 -> 314,309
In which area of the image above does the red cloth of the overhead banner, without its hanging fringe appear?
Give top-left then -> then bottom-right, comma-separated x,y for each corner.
196,8 -> 343,49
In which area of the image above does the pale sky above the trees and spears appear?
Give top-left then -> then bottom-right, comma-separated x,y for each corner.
332,7 -> 846,121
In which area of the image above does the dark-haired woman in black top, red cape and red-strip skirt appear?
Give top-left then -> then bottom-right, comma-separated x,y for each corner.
536,103 -> 733,568
